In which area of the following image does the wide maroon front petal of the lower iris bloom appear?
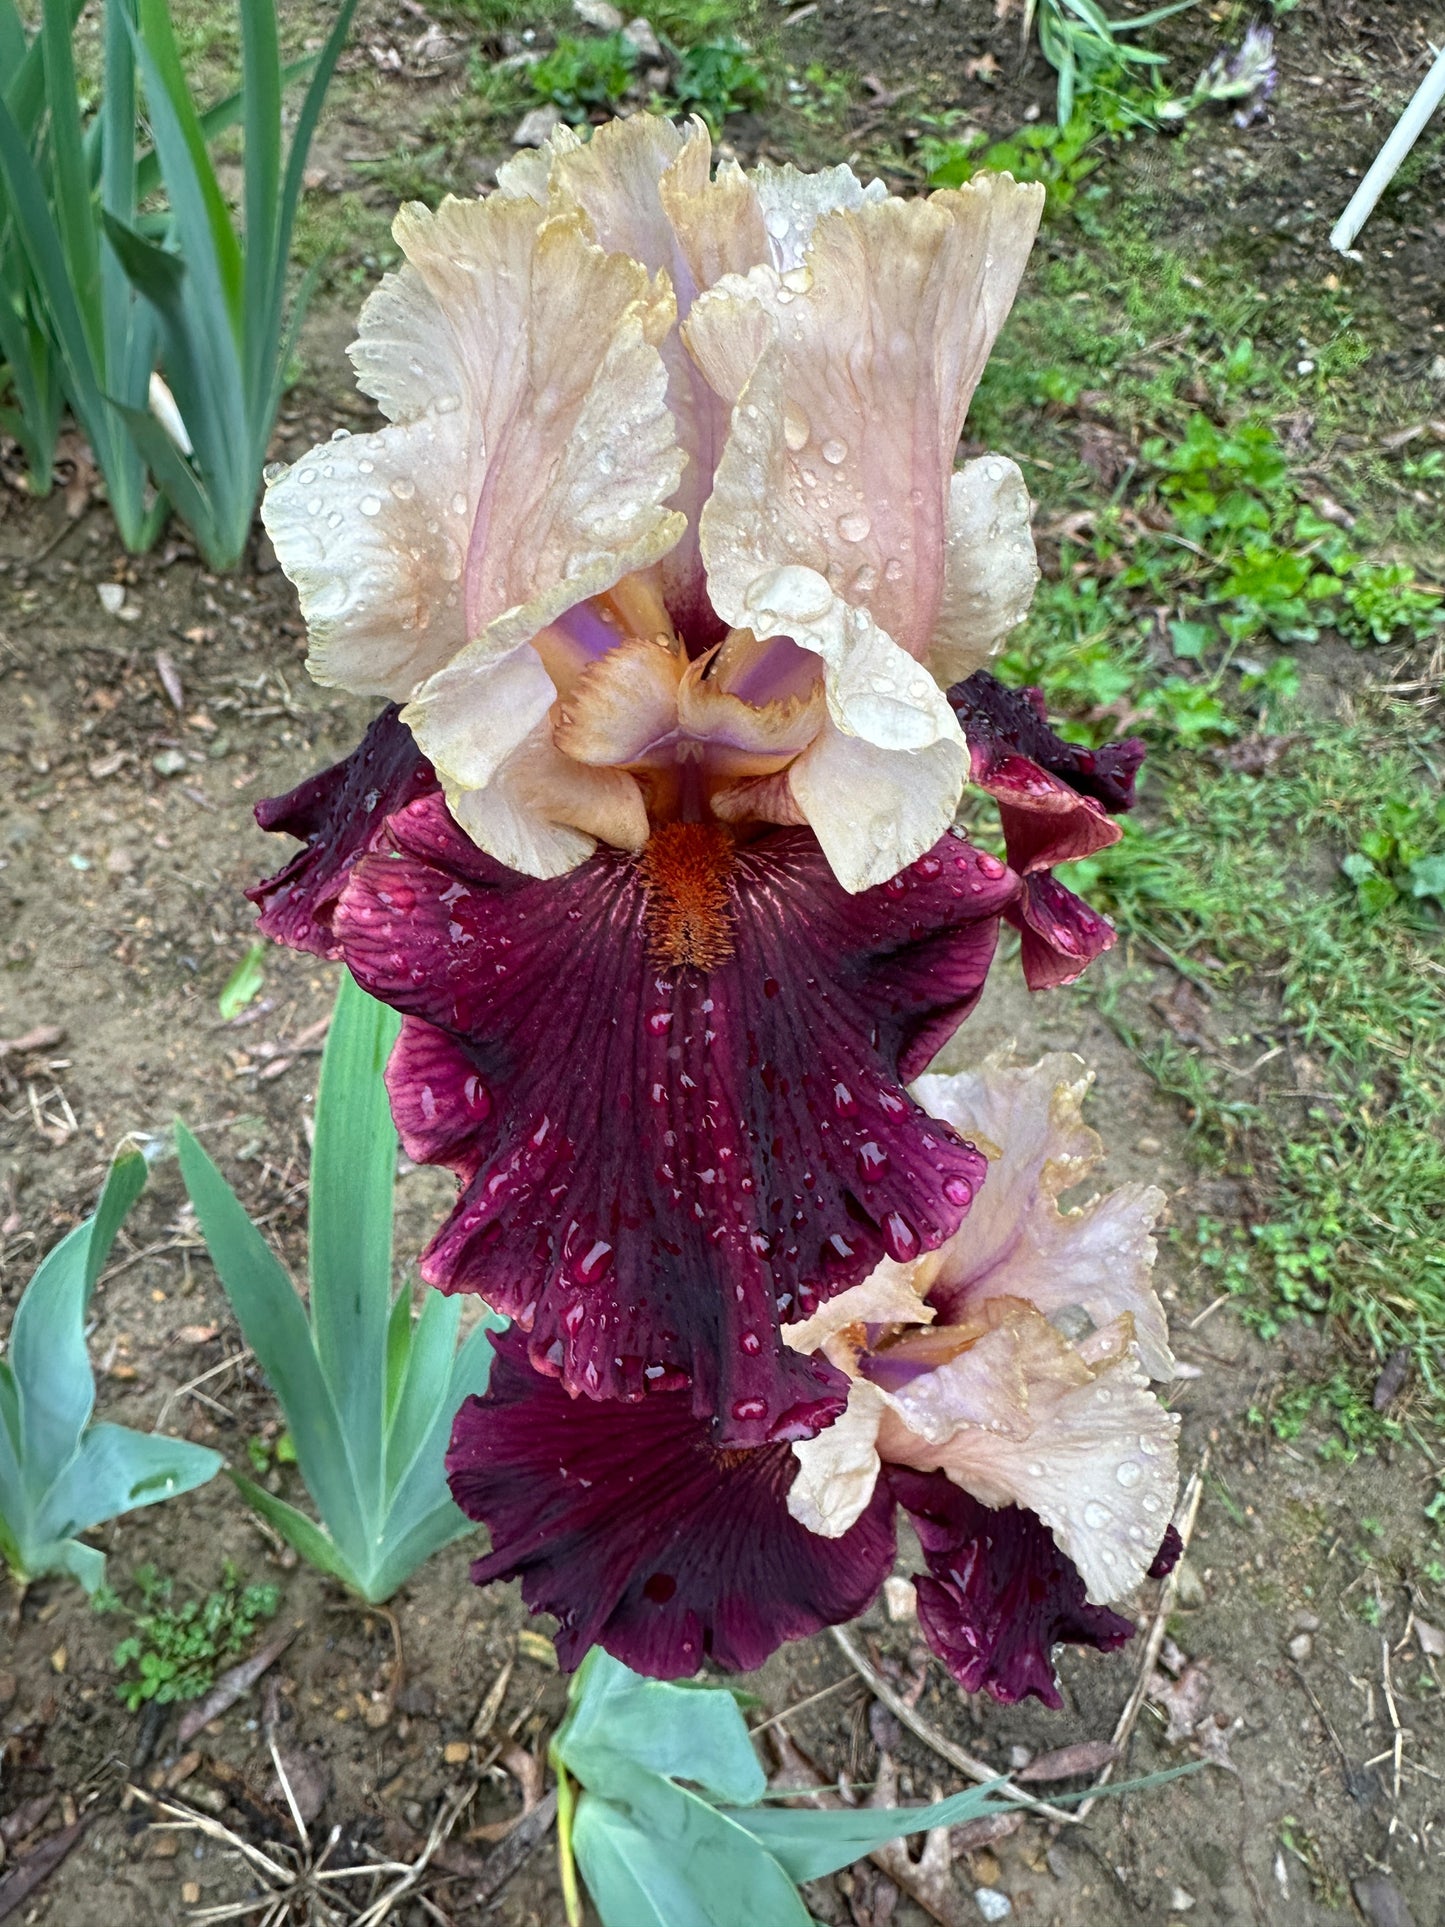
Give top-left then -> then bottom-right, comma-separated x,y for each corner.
447,1332 -> 894,1678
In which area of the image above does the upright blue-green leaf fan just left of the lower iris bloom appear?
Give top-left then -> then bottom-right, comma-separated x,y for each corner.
175,977 -> 501,1601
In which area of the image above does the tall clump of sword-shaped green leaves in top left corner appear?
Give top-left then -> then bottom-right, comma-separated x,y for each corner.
0,0 -> 356,568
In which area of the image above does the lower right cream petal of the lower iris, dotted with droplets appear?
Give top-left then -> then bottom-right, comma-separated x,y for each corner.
877,1299 -> 1179,1603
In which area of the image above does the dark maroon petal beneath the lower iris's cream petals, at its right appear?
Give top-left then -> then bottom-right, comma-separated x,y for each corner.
888,1466 -> 1135,1707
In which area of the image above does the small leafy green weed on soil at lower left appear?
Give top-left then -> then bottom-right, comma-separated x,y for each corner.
94,1559 -> 279,1713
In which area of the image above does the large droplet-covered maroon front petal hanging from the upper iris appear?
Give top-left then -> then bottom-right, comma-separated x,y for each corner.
335,798 -> 1019,1443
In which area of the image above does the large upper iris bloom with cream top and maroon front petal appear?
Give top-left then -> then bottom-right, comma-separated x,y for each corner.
254,116 -> 1071,1445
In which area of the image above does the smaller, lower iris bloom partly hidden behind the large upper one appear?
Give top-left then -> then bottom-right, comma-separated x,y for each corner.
449,1056 -> 1177,1705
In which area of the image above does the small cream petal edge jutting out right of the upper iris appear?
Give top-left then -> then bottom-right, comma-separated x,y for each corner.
929,455 -> 1038,688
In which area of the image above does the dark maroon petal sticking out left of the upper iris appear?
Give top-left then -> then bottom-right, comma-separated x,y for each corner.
247,703 -> 437,958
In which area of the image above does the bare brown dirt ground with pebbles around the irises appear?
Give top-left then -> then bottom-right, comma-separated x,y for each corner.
0,0 -> 1445,1927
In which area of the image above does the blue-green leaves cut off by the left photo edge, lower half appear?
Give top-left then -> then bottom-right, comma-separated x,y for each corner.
0,1150 -> 222,1592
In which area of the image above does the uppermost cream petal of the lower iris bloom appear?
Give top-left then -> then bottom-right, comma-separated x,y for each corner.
913,1052 -> 1175,1380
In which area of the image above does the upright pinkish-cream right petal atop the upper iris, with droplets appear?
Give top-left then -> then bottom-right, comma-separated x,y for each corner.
684,175 -> 1042,659
